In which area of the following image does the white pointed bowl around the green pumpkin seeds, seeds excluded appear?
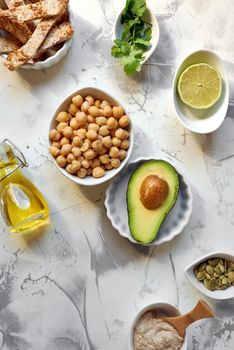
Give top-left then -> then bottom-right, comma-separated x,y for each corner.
184,251 -> 234,300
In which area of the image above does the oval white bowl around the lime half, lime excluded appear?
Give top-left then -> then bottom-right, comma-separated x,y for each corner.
172,50 -> 229,134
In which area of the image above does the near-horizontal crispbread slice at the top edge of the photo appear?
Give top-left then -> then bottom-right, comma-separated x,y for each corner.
7,0 -> 61,22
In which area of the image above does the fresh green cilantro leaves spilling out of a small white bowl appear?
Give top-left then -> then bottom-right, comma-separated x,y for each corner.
111,0 -> 152,76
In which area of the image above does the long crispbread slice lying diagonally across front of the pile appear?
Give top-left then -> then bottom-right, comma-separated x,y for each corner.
4,18 -> 57,70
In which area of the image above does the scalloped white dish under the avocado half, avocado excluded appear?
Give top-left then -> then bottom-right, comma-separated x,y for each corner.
105,157 -> 192,245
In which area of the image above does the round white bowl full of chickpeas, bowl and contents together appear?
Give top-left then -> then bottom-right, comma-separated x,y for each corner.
49,87 -> 133,186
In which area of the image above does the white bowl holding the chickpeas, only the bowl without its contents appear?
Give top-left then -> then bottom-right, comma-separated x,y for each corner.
49,87 -> 134,186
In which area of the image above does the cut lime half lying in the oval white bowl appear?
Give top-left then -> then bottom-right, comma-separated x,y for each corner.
177,63 -> 222,109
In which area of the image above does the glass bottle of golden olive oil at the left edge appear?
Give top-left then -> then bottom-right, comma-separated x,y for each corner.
0,144 -> 49,232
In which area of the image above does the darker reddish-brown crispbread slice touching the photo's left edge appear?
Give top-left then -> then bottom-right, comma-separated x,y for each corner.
0,10 -> 32,44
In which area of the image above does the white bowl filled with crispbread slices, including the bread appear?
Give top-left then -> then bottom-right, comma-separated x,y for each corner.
0,0 -> 74,71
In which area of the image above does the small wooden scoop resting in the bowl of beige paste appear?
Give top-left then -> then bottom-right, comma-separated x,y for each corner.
162,300 -> 215,338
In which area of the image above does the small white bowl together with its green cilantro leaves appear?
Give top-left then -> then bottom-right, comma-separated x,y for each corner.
111,0 -> 159,76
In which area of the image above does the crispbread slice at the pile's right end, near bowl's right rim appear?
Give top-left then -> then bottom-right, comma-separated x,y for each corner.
38,22 -> 74,55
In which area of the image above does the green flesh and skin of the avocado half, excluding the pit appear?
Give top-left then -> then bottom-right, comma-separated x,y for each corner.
127,160 -> 179,244
